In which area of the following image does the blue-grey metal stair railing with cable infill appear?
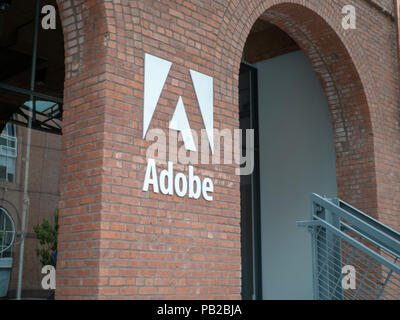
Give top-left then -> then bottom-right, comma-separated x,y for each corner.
297,194 -> 400,300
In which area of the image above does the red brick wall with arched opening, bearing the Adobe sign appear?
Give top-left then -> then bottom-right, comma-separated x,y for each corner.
56,0 -> 400,299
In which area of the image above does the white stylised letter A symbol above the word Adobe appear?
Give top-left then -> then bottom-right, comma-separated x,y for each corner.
143,53 -> 214,153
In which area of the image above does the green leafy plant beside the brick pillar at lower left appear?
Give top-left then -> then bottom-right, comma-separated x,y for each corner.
33,208 -> 59,266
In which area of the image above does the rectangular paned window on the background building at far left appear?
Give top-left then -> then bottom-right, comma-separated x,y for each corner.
0,123 -> 18,182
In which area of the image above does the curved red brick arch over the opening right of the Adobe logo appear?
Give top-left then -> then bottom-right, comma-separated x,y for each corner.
220,1 -> 378,217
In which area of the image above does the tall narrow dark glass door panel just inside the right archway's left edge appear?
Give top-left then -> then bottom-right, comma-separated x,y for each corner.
239,63 -> 262,300
